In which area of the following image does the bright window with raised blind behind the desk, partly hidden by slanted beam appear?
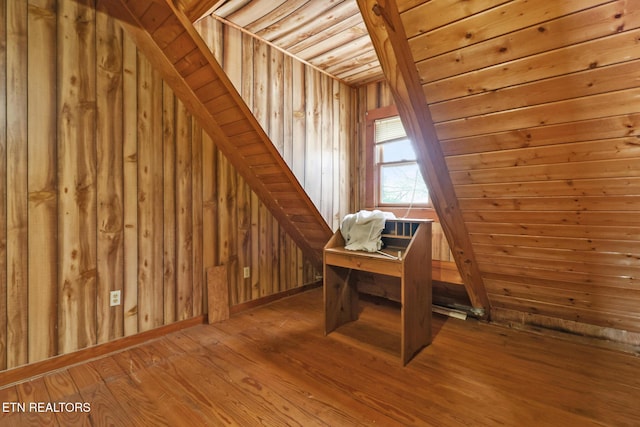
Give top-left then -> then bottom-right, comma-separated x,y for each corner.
372,116 -> 429,206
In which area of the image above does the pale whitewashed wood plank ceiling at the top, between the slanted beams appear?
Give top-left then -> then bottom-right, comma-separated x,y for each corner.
179,0 -> 383,86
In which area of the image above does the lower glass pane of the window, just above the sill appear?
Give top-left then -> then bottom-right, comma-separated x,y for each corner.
380,163 -> 429,204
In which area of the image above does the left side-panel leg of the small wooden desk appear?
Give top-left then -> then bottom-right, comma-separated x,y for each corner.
324,264 -> 358,335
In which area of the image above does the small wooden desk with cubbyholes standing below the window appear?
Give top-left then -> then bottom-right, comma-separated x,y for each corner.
323,219 -> 432,365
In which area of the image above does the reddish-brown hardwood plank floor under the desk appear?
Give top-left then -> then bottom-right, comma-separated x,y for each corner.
0,289 -> 640,427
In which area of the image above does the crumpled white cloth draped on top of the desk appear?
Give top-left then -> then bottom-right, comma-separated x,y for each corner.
340,210 -> 395,252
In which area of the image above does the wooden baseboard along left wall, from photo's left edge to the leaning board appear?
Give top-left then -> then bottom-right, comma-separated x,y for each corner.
0,315 -> 205,387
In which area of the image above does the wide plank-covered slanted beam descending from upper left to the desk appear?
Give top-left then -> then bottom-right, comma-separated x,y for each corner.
101,0 -> 333,267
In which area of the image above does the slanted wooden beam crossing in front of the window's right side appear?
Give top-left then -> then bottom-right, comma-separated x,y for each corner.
358,0 -> 491,318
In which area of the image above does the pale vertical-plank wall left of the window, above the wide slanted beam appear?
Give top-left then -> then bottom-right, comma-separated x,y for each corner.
195,16 -> 356,230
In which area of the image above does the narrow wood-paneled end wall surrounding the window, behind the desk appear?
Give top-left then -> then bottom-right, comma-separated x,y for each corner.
351,81 -> 453,262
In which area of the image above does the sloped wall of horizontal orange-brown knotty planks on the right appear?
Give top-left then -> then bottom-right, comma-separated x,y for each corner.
399,0 -> 640,344
